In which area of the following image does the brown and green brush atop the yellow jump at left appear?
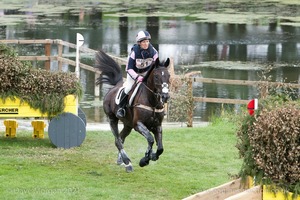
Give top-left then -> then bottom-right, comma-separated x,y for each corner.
0,44 -> 82,116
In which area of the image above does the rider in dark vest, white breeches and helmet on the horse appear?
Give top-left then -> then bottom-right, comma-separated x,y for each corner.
117,31 -> 158,118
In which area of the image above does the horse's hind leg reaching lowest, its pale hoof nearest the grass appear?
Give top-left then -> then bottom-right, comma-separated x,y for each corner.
109,119 -> 133,172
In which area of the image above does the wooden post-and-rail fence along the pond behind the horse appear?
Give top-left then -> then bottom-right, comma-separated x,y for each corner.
0,39 -> 300,126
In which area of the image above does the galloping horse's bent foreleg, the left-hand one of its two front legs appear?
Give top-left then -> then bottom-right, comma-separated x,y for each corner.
134,121 -> 154,167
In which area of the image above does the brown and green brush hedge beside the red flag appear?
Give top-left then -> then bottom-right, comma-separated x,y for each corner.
237,69 -> 300,197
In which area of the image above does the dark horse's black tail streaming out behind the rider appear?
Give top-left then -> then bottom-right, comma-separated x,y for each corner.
95,50 -> 123,85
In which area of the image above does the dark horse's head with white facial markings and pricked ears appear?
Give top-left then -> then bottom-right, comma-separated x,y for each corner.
151,58 -> 170,103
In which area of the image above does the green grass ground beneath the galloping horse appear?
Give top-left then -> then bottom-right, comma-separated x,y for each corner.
0,120 -> 241,200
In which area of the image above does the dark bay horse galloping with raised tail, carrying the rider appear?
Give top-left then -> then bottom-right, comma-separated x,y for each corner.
95,50 -> 170,172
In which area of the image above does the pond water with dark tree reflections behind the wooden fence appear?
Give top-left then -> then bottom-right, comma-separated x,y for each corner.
0,1 -> 300,122
